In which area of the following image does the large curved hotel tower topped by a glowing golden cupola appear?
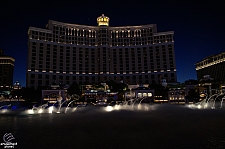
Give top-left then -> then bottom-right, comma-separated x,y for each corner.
27,14 -> 177,88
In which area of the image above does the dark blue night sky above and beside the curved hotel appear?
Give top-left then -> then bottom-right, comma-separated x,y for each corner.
0,0 -> 225,86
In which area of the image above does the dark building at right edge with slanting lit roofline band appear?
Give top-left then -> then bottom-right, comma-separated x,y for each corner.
195,52 -> 225,83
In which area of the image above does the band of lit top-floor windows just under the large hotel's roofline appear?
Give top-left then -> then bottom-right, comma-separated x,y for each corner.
30,27 -> 173,46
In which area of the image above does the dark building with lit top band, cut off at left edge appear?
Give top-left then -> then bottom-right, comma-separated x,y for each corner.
0,49 -> 15,91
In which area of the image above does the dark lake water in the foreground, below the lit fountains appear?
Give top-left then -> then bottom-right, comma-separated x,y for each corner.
0,105 -> 225,149
